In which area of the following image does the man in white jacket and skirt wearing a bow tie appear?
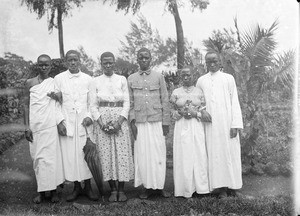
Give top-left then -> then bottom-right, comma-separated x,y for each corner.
54,50 -> 97,201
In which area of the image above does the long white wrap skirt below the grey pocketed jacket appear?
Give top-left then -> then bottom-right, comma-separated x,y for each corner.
134,122 -> 166,189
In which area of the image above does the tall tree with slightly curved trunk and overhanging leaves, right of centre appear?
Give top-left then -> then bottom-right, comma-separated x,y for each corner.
104,0 -> 209,69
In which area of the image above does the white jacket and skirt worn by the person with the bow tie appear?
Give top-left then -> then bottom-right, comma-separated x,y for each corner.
54,71 -> 92,181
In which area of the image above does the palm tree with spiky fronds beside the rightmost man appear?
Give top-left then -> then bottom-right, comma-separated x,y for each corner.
204,18 -> 295,165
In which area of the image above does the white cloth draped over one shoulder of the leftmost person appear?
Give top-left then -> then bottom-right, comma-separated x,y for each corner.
29,78 -> 64,192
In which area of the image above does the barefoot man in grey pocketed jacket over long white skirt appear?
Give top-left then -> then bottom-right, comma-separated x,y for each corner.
128,48 -> 170,199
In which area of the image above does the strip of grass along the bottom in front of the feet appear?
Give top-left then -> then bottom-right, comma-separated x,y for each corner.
1,196 -> 293,216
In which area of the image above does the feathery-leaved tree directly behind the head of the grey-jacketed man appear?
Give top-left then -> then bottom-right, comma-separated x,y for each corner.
116,16 -> 205,89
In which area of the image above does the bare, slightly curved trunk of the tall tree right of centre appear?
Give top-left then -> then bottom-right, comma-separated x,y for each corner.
171,0 -> 185,69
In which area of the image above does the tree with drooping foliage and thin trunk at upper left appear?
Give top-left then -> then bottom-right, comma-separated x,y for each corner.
21,0 -> 84,58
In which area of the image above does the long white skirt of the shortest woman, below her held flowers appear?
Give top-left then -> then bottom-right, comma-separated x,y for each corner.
173,118 -> 209,198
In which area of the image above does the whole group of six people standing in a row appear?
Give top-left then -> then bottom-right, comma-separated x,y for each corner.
24,48 -> 243,203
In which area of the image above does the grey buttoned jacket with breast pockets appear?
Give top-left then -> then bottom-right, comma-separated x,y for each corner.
128,70 -> 170,125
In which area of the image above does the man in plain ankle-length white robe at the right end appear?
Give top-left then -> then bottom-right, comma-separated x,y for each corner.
196,52 -> 243,198
